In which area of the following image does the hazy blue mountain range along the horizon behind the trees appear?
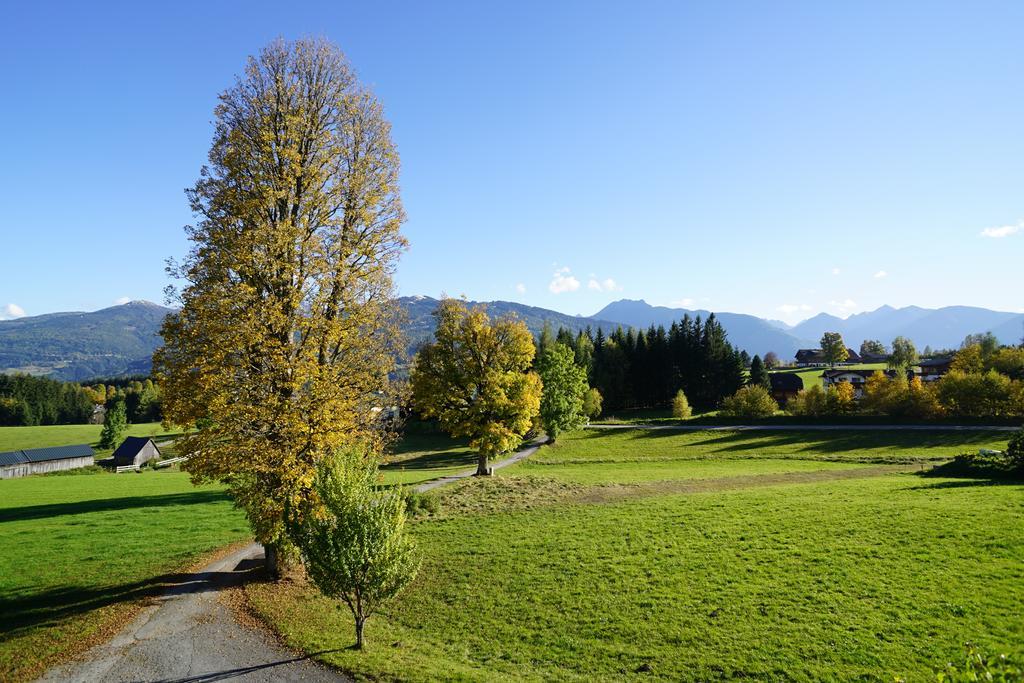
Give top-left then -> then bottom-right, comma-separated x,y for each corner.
0,296 -> 1024,381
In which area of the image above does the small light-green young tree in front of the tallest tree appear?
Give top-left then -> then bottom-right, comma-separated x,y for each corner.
292,451 -> 420,649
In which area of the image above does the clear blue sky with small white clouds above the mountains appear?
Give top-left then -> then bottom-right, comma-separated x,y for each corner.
0,0 -> 1024,322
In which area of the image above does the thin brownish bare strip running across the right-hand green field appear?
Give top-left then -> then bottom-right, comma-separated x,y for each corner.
577,465 -> 921,503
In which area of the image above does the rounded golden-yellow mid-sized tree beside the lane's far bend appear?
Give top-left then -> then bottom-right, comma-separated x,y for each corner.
412,299 -> 541,475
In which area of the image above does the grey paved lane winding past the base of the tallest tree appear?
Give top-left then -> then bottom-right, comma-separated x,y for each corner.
40,440 -> 542,683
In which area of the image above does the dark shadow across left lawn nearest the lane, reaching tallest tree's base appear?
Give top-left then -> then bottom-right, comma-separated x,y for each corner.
0,560 -> 265,641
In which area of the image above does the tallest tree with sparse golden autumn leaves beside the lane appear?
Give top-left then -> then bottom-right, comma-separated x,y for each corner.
154,40 -> 406,569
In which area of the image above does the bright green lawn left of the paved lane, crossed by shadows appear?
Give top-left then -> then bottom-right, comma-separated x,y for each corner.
0,471 -> 249,681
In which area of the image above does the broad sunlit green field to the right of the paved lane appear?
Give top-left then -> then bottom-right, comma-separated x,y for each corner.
241,431 -> 1024,681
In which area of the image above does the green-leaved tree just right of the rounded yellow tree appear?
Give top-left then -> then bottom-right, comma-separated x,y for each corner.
537,343 -> 587,442
